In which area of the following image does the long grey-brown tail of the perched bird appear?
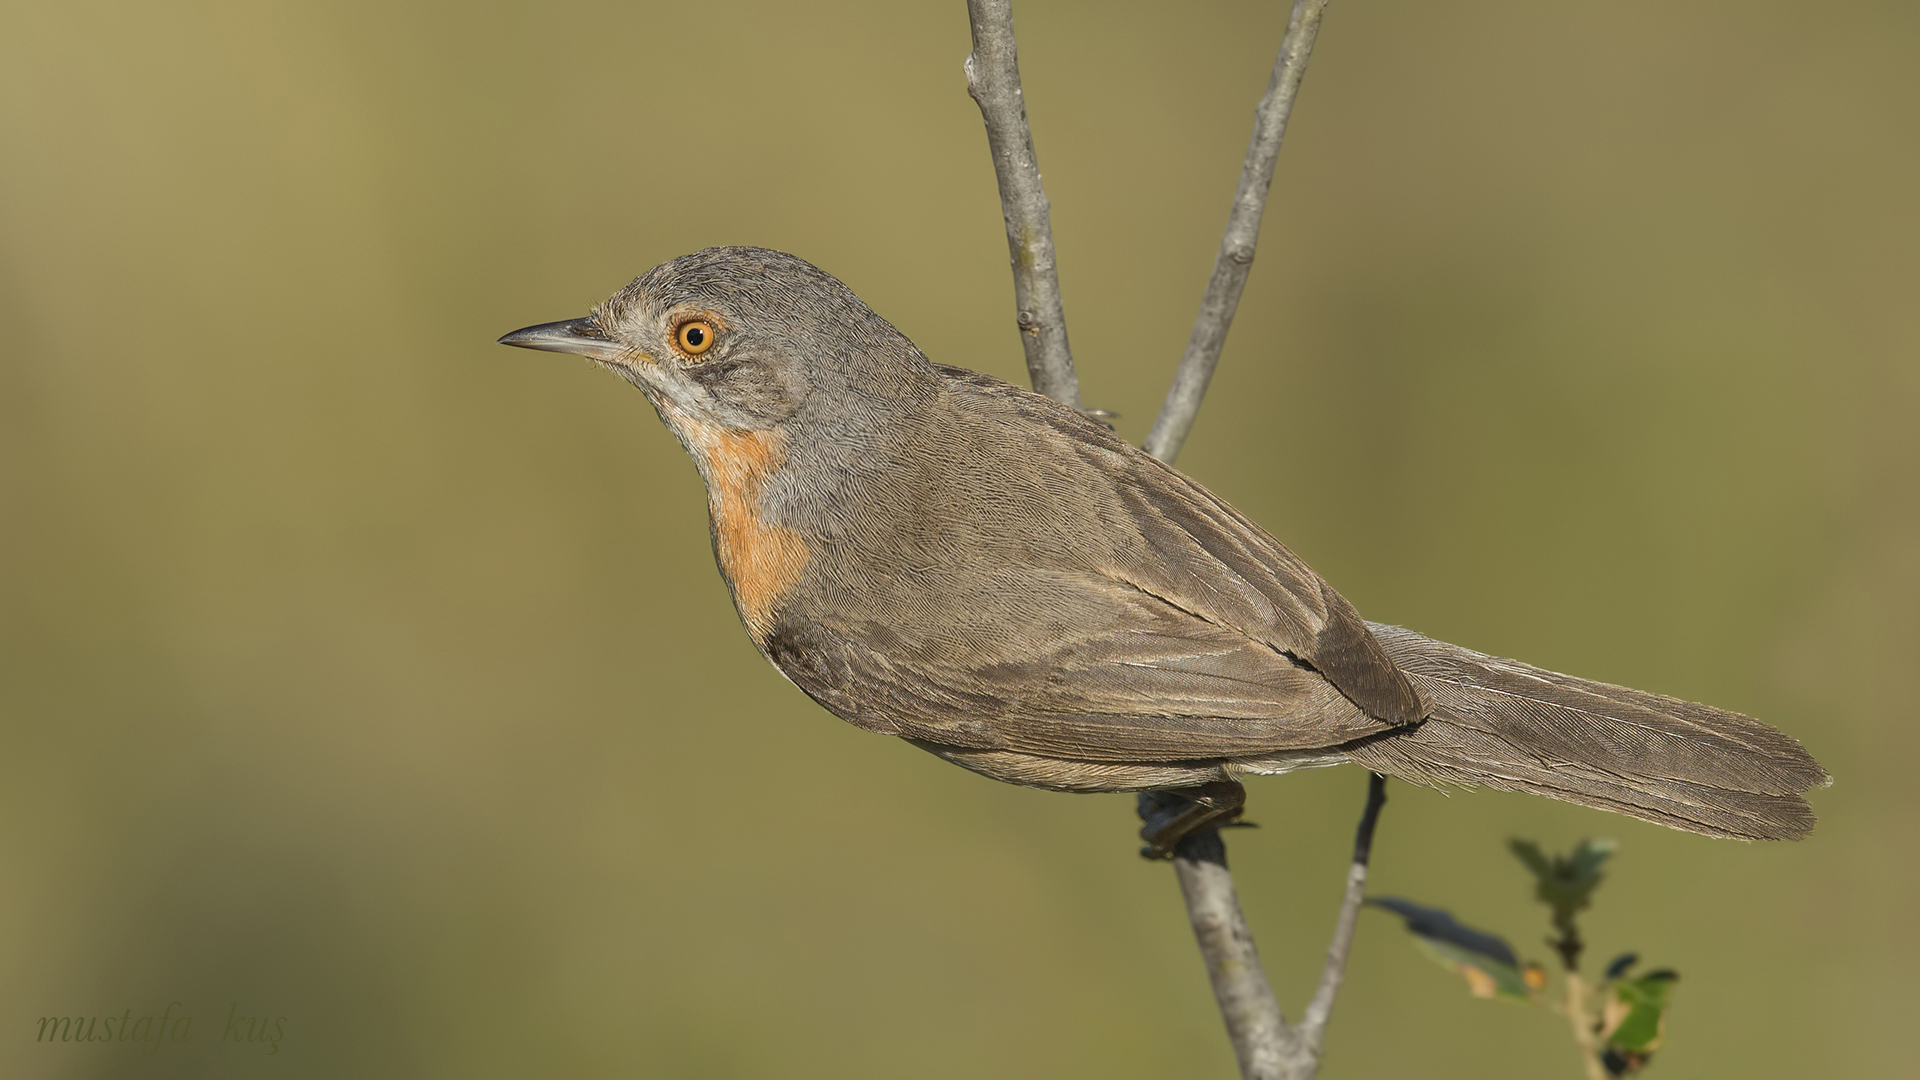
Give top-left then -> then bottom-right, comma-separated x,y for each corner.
1344,623 -> 1828,840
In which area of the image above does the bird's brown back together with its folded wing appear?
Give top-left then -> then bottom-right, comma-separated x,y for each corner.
760,369 -> 1427,763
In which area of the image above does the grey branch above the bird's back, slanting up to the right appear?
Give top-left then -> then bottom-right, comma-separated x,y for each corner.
1144,0 -> 1327,463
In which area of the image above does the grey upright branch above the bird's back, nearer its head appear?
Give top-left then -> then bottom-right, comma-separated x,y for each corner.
966,0 -> 1081,409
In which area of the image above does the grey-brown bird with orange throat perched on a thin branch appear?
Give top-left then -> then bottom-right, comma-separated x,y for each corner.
499,246 -> 1830,857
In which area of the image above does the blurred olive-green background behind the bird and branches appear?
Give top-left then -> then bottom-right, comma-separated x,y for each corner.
0,0 -> 1920,1080
